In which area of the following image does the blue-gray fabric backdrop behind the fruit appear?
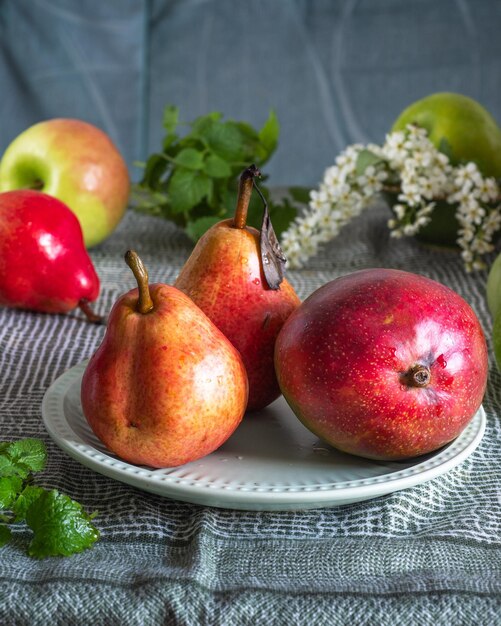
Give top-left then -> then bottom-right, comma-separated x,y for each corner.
0,0 -> 501,185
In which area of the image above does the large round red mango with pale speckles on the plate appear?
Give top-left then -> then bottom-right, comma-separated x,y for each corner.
275,269 -> 487,460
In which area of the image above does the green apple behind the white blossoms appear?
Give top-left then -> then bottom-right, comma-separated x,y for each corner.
392,92 -> 501,245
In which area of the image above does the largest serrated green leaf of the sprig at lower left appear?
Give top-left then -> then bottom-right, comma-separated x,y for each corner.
26,489 -> 99,559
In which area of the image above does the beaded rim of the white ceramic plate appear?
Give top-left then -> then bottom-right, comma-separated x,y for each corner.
42,359 -> 487,511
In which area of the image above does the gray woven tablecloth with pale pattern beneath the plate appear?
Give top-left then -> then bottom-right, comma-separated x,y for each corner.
0,209 -> 501,626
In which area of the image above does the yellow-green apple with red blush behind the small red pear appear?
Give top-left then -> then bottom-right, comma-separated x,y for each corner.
0,118 -> 130,247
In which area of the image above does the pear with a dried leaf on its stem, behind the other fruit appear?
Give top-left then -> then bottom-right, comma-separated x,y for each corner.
174,166 -> 300,410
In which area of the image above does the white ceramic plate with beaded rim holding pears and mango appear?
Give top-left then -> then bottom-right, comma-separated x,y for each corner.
42,363 -> 485,511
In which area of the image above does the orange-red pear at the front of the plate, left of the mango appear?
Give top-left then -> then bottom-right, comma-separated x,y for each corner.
81,251 -> 248,467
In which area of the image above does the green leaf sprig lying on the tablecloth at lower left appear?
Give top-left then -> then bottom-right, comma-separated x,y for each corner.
0,439 -> 99,558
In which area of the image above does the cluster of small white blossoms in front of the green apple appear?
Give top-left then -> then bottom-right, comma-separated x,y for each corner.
281,125 -> 501,271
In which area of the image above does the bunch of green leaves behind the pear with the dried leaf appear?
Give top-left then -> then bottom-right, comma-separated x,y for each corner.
133,106 -> 297,241
